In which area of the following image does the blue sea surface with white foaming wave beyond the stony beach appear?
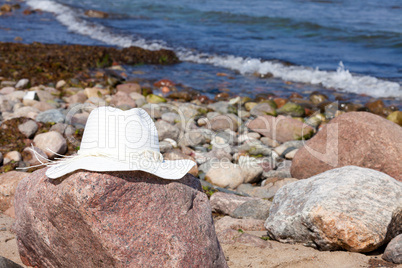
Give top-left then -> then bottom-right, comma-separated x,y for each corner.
0,0 -> 402,103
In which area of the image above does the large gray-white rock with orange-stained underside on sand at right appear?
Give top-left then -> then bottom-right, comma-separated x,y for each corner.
265,166 -> 402,252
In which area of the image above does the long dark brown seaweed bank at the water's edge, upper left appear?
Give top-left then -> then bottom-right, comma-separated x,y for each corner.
0,42 -> 179,85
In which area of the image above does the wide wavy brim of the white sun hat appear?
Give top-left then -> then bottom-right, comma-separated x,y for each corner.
46,156 -> 196,180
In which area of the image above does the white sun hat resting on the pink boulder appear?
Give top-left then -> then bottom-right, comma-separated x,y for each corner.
42,107 -> 195,180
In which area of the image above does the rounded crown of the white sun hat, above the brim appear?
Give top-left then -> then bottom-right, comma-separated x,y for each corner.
78,107 -> 160,159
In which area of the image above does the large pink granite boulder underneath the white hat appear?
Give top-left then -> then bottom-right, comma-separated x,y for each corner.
14,169 -> 227,267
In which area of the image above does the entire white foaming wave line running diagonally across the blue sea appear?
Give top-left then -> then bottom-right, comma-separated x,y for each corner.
27,0 -> 402,99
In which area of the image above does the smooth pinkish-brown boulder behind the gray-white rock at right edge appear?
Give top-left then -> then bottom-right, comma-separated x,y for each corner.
290,112 -> 402,181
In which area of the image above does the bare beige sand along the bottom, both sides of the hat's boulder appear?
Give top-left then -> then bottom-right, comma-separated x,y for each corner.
0,213 -> 402,268
